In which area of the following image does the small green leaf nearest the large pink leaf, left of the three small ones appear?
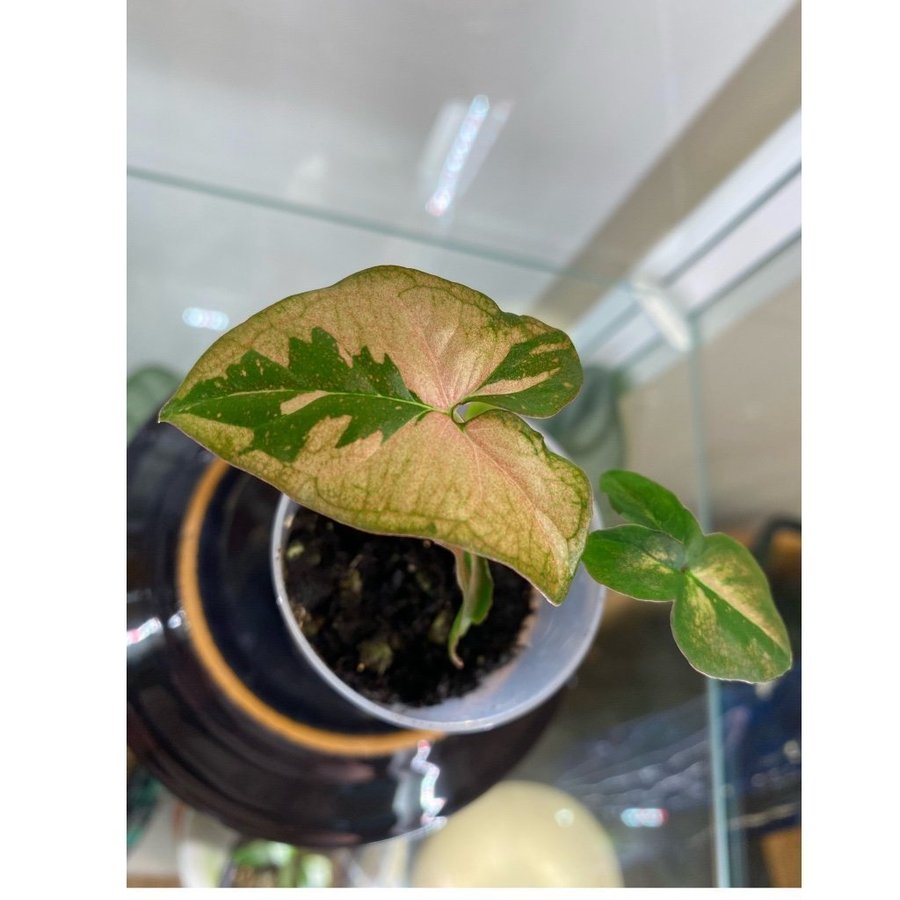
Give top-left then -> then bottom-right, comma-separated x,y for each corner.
582,525 -> 684,600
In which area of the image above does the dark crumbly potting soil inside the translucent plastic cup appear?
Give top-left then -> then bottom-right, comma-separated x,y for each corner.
284,508 -> 536,706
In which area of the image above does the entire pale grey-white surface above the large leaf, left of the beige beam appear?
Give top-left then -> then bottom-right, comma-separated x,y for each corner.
128,0 -> 793,371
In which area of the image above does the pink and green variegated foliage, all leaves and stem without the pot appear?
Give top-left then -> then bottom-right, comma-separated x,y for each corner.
160,266 -> 790,680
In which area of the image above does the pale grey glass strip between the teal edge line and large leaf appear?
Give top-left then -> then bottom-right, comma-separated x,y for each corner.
128,171 -> 584,373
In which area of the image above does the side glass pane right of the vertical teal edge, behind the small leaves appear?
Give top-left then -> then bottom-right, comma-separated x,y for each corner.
700,278 -> 802,887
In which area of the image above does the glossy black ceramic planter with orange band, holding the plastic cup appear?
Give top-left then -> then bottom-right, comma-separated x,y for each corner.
127,422 -> 576,847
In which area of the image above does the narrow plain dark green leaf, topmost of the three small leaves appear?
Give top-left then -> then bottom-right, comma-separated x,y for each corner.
600,469 -> 703,545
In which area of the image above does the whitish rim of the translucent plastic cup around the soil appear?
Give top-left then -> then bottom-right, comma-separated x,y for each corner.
270,435 -> 606,733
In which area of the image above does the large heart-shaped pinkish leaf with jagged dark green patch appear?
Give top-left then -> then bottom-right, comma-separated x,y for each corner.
160,266 -> 591,602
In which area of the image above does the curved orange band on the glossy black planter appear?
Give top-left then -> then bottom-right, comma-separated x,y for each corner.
176,459 -> 443,756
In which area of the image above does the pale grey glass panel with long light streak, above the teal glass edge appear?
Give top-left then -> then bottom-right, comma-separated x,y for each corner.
128,0 -> 792,282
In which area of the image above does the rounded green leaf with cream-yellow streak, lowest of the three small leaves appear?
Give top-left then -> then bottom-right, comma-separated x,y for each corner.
672,534 -> 791,682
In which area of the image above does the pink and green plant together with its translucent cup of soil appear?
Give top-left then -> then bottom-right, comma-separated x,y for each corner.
160,266 -> 791,731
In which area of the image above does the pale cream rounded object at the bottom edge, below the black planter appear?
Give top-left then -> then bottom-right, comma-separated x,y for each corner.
412,781 -> 622,888
